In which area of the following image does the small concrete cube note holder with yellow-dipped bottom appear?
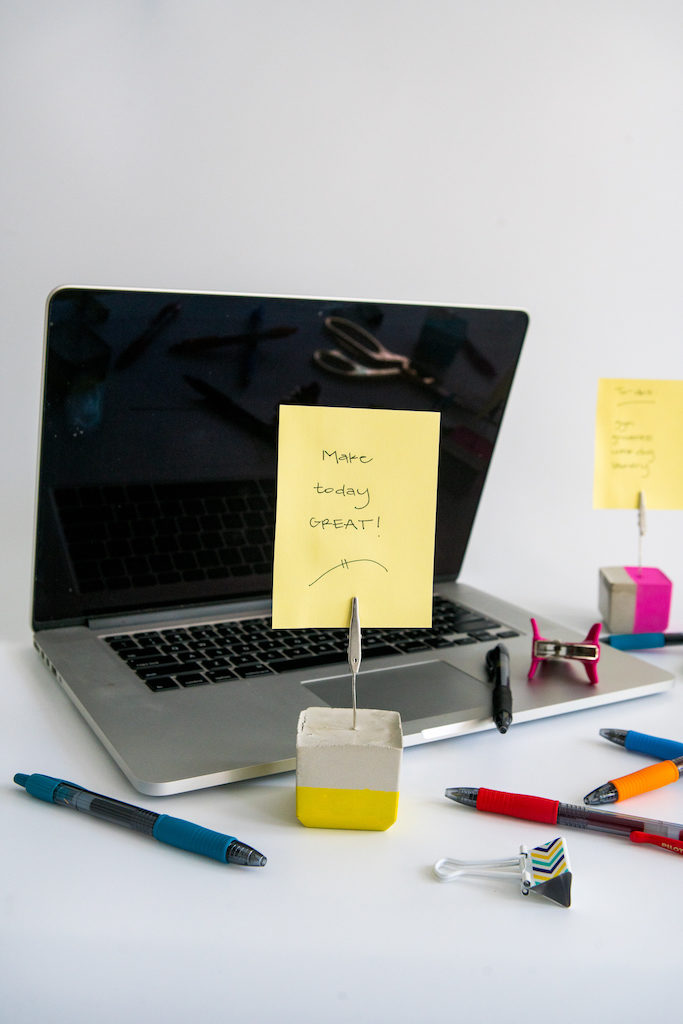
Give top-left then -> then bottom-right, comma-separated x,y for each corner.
296,708 -> 403,831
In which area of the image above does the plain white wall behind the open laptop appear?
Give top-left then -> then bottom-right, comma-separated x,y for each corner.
0,0 -> 683,647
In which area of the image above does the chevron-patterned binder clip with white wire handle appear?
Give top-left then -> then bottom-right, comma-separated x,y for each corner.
433,836 -> 571,906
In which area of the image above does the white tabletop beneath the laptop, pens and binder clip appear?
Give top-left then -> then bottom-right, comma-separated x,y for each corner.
0,561 -> 683,1024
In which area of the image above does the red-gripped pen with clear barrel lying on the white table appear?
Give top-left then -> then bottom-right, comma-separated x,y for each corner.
445,787 -> 683,854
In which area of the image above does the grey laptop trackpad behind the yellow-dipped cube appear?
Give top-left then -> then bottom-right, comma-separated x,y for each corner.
304,662 -> 490,722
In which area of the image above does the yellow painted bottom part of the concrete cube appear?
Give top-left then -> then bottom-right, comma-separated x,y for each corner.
296,785 -> 398,831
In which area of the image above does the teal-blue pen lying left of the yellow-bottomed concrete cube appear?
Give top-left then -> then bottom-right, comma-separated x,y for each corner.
14,773 -> 266,867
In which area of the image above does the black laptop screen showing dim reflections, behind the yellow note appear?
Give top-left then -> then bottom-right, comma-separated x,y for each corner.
33,288 -> 527,629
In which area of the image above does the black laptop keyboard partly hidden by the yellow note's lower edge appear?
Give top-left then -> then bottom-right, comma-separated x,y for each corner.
103,596 -> 518,692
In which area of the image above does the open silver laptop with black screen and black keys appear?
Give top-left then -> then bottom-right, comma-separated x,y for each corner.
33,287 -> 673,796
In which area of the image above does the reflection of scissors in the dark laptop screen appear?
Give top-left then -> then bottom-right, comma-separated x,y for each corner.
313,316 -> 438,390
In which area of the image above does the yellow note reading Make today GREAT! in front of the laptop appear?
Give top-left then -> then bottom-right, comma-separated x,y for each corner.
272,406 -> 440,629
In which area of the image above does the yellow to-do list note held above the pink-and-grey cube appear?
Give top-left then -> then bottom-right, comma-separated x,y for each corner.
593,379 -> 683,509
